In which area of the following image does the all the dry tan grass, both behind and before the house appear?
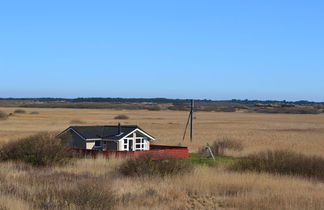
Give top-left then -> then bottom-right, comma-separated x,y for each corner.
0,108 -> 324,209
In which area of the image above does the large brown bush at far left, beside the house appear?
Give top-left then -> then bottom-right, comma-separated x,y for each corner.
0,133 -> 72,166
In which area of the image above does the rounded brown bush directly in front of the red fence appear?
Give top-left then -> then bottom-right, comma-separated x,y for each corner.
119,154 -> 193,176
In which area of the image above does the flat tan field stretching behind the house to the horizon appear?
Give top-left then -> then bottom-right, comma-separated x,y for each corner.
0,107 -> 324,156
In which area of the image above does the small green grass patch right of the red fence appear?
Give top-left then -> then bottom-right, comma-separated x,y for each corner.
187,153 -> 237,166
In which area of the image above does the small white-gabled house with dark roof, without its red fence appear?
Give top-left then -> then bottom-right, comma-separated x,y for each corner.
58,124 -> 155,151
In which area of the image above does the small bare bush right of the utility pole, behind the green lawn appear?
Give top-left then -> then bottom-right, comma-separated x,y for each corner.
199,138 -> 243,156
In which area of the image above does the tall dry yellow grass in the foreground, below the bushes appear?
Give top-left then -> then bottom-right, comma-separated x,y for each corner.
0,158 -> 324,210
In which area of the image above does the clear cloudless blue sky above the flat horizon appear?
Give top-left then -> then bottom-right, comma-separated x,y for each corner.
0,0 -> 324,101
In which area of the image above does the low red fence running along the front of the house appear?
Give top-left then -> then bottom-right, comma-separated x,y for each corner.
74,145 -> 189,158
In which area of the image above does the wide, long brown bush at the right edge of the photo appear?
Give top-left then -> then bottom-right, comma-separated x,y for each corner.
230,150 -> 324,179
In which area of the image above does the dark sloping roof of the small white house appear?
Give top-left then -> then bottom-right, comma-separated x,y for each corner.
63,125 -> 153,140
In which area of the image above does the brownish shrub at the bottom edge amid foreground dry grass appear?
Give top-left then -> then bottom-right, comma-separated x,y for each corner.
62,182 -> 117,209
